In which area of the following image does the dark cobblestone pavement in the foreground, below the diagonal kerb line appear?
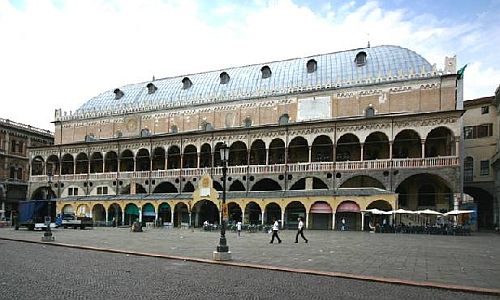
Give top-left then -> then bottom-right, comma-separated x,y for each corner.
0,240 -> 496,300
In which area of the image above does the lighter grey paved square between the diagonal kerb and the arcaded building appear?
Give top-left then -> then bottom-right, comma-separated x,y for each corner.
0,228 -> 500,290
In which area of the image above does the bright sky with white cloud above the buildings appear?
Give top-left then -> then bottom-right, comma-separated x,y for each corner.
0,0 -> 500,131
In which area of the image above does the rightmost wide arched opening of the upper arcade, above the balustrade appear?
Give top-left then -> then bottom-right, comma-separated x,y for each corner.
425,127 -> 455,157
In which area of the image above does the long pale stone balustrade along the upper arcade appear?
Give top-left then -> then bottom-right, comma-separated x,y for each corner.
30,156 -> 460,182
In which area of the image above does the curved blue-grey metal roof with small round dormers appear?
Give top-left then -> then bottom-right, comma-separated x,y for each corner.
76,46 -> 432,115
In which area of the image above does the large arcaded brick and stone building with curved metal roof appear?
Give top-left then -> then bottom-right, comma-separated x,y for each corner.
30,46 -> 462,230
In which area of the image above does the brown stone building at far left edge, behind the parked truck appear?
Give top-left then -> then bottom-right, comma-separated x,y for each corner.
0,119 -> 54,220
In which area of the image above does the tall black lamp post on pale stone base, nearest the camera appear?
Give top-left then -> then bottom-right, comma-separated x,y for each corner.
213,144 -> 231,260
